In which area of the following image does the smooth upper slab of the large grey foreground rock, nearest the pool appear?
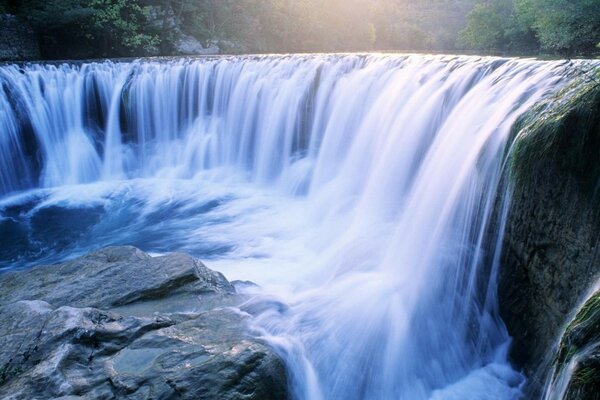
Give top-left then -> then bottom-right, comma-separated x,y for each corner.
0,247 -> 235,311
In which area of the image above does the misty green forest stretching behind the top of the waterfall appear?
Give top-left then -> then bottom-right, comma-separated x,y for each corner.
0,0 -> 600,58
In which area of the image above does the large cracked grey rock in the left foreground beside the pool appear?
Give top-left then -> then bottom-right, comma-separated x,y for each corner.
0,247 -> 287,400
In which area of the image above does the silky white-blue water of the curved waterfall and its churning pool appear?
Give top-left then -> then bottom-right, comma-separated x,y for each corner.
0,55 -> 580,400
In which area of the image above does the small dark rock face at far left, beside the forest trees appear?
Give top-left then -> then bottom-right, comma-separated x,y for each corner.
0,14 -> 40,61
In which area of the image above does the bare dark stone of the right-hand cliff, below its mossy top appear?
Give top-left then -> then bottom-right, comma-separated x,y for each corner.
499,159 -> 600,384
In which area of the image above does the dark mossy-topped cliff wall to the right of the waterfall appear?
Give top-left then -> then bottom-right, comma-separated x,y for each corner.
499,69 -> 600,398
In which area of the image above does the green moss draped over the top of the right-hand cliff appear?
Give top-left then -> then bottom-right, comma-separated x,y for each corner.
509,66 -> 600,208
